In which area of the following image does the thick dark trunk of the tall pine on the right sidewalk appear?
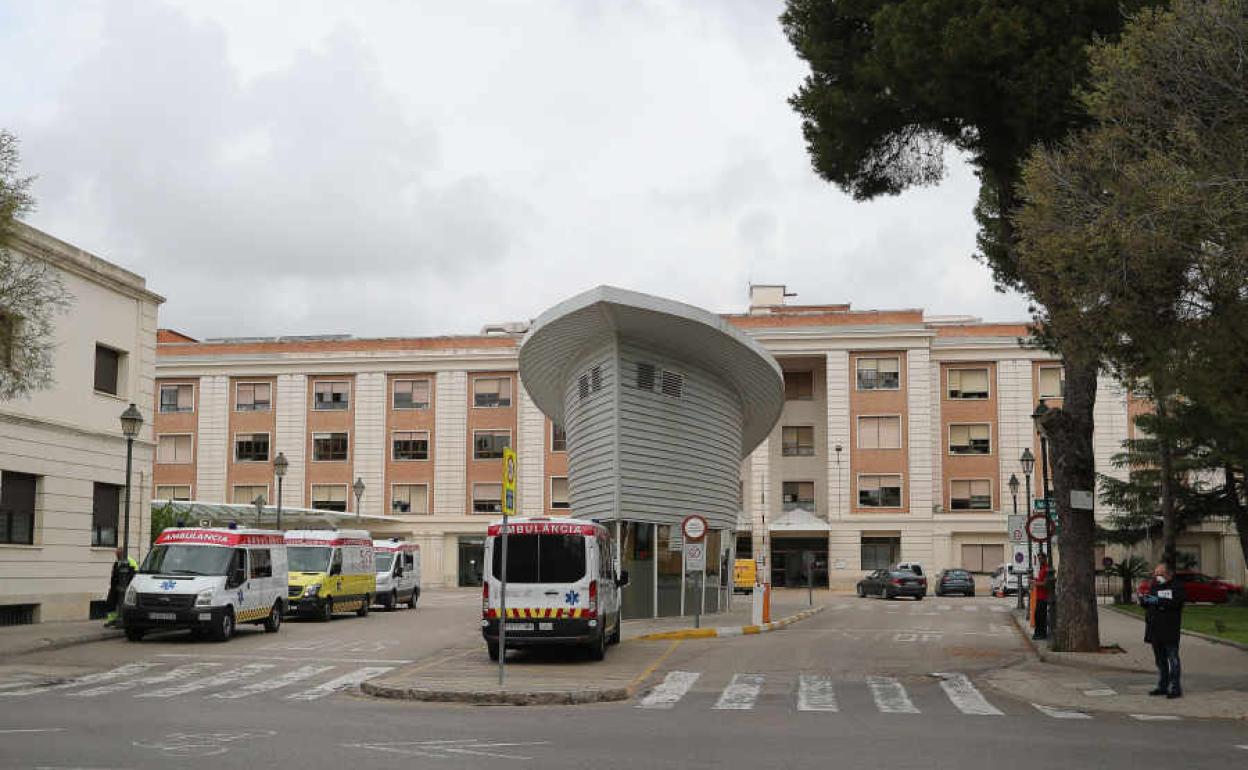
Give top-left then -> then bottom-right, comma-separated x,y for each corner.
1041,356 -> 1101,653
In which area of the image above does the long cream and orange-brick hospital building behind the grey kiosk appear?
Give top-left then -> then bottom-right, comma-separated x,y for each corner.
152,286 -> 1244,585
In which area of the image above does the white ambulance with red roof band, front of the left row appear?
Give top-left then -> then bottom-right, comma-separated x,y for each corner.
121,528 -> 286,641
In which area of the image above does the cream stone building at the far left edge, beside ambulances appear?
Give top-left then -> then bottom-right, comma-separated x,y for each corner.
0,225 -> 163,625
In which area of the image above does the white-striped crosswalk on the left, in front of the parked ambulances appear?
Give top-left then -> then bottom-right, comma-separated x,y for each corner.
0,661 -> 394,703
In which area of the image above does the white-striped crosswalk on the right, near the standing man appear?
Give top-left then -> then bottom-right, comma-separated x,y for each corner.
634,671 -> 1177,720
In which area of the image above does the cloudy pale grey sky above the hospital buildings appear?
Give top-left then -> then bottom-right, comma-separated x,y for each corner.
0,0 -> 1025,337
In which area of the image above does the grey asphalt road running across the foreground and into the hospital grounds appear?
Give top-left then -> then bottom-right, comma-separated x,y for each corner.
0,592 -> 1248,770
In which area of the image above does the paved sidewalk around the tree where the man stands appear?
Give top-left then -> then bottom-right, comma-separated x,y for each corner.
988,607 -> 1248,719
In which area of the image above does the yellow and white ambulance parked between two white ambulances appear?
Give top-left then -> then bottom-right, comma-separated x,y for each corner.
286,529 -> 377,620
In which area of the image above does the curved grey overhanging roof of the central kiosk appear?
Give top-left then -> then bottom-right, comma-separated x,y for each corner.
520,286 -> 784,457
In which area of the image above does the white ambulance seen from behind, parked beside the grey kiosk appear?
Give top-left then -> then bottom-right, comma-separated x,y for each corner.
480,518 -> 628,660
